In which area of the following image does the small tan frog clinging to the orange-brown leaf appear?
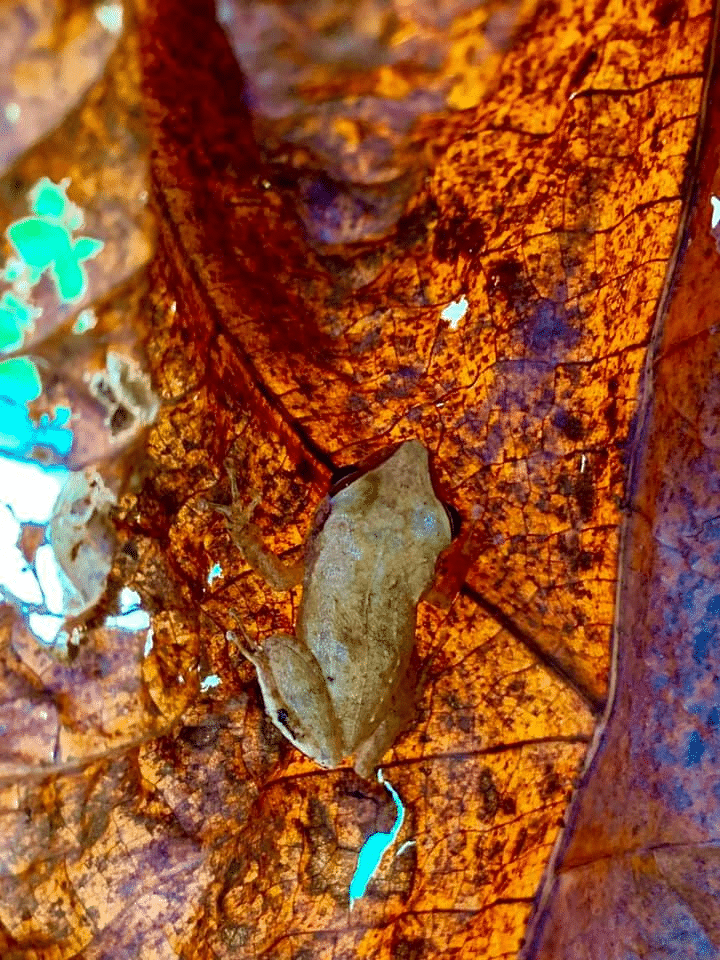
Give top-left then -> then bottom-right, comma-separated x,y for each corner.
215,440 -> 452,778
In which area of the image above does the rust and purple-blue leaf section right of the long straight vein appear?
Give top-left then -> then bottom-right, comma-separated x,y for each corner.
524,26 -> 720,960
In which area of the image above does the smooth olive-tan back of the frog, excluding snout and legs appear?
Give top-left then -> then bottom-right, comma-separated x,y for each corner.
298,454 -> 450,753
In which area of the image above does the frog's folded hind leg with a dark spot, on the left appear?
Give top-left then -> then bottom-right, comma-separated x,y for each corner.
228,630 -> 344,767
